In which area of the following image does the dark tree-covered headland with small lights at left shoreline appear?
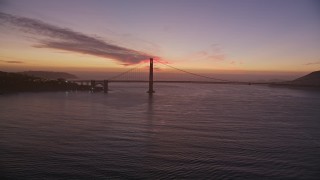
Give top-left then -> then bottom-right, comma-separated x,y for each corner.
0,71 -> 89,94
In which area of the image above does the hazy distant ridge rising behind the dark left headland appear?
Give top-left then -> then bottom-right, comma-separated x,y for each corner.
21,71 -> 78,79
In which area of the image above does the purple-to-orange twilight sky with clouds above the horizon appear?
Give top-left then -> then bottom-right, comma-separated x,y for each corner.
0,0 -> 320,72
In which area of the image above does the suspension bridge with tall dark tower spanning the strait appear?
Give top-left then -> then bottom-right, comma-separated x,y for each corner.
73,58 -> 264,94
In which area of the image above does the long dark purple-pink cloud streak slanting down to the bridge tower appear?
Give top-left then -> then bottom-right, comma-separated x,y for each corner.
0,12 -> 153,65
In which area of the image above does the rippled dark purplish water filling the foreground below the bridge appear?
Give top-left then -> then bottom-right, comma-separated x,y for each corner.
0,83 -> 320,179
